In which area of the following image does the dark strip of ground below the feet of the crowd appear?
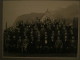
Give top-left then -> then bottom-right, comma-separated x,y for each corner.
3,52 -> 77,57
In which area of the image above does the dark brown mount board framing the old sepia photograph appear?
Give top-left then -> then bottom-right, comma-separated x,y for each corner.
0,0 -> 80,60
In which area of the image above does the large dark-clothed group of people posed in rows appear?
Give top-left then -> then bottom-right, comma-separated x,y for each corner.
4,19 -> 77,53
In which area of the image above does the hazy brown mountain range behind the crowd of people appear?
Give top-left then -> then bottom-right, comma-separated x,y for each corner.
15,4 -> 80,23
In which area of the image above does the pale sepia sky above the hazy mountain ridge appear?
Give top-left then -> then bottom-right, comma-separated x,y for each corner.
3,1 -> 79,29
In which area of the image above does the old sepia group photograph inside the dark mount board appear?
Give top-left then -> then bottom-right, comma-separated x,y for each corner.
2,1 -> 80,57
